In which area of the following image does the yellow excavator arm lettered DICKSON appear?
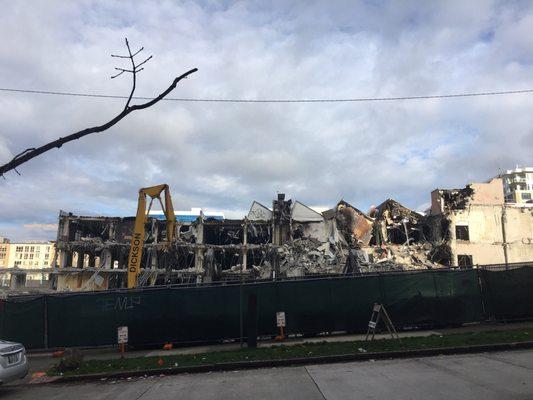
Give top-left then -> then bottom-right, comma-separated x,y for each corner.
128,184 -> 176,288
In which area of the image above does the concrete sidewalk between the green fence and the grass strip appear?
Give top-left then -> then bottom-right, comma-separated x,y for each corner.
16,321 -> 533,384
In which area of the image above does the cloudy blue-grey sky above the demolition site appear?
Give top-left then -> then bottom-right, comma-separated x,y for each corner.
0,0 -> 533,240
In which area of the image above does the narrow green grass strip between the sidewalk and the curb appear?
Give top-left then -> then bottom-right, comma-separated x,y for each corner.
47,328 -> 533,376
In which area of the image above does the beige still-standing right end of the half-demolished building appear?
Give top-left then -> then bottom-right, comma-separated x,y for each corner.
430,178 -> 533,267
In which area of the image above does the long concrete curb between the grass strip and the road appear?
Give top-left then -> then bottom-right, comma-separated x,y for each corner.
38,341 -> 533,386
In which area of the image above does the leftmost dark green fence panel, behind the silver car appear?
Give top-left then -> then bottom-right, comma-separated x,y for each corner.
0,296 -> 45,348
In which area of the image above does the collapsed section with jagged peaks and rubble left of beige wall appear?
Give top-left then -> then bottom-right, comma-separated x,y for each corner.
279,199 -> 445,277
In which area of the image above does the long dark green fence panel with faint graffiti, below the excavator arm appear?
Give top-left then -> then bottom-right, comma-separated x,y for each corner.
48,286 -> 244,347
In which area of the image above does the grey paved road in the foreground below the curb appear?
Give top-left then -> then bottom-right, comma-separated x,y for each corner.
0,350 -> 533,400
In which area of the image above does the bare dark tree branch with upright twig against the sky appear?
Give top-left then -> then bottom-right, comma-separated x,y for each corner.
0,39 -> 198,176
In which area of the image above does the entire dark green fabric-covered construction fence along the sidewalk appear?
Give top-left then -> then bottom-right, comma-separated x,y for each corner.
0,267 -> 533,348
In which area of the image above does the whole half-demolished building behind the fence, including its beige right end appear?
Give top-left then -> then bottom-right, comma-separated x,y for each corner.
33,179 -> 533,290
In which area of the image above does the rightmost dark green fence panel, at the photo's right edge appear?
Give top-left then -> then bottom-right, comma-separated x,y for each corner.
479,267 -> 533,319
